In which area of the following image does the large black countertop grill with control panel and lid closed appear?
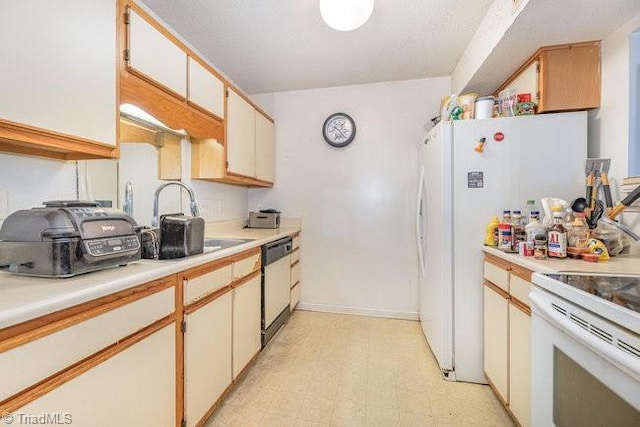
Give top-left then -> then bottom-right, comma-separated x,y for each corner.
0,200 -> 140,277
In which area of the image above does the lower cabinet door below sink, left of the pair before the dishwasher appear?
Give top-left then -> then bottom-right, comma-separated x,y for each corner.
184,292 -> 232,426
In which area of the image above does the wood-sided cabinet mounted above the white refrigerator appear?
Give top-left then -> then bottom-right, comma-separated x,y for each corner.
494,41 -> 601,113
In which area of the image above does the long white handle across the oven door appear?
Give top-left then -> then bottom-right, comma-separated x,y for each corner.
529,292 -> 640,381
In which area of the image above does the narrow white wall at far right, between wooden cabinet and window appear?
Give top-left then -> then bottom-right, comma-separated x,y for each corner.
589,16 -> 640,236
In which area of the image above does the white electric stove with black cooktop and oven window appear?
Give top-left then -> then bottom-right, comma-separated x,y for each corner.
531,273 -> 640,427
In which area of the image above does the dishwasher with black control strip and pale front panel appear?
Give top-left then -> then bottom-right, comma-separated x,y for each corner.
262,237 -> 292,347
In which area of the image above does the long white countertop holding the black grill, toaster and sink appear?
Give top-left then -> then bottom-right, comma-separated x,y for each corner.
0,226 -> 300,329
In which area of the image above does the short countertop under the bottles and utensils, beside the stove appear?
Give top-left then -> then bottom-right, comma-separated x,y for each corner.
483,246 -> 640,275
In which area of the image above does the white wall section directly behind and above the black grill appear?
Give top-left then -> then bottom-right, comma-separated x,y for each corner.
0,153 -> 76,222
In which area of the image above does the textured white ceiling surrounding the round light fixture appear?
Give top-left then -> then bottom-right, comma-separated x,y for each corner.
143,0 -> 492,94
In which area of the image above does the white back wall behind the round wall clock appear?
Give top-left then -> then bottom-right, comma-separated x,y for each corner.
249,77 -> 451,319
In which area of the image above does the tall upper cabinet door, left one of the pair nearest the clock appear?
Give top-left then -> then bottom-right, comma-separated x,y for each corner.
226,89 -> 256,178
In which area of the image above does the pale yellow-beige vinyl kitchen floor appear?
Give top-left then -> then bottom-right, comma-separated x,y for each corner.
206,310 -> 514,427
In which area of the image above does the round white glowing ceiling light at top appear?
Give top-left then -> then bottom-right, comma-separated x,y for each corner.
320,0 -> 374,31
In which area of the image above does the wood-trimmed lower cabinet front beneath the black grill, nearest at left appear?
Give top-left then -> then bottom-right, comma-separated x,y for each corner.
0,276 -> 178,427
